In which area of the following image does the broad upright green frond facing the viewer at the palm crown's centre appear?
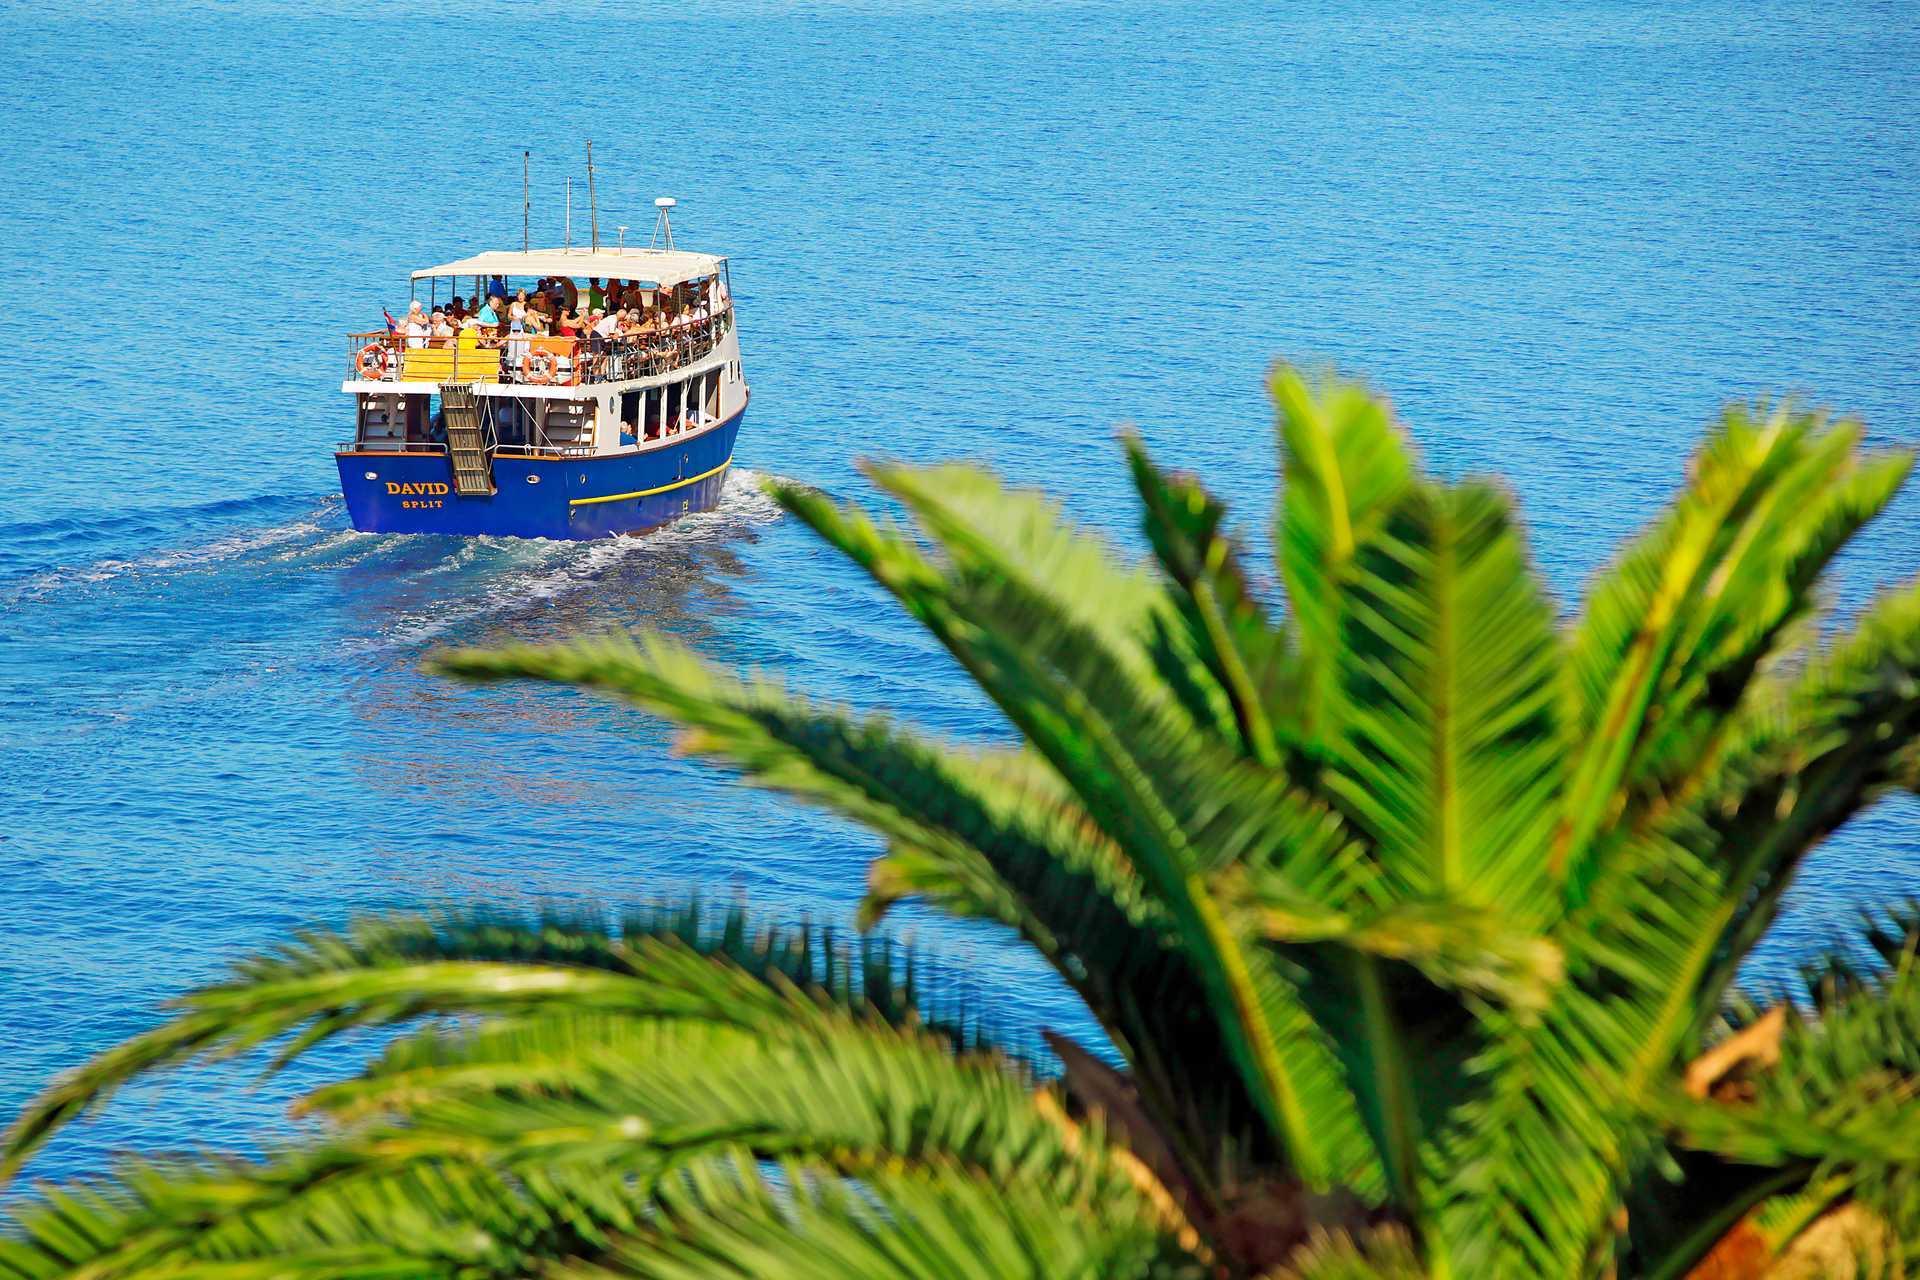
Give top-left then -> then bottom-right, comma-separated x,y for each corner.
1323,484 -> 1565,927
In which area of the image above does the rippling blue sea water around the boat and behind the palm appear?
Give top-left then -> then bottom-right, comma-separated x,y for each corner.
0,0 -> 1920,1174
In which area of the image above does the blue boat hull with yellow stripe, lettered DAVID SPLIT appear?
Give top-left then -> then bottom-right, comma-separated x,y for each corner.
336,409 -> 747,539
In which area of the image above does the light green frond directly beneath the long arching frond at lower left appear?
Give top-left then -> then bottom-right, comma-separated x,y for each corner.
299,992 -> 1131,1190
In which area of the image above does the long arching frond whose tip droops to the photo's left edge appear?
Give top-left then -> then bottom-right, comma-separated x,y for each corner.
0,908 -> 970,1176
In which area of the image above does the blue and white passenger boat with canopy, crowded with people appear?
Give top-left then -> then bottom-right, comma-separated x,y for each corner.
334,198 -> 747,539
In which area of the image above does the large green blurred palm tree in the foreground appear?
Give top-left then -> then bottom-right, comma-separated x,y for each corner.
0,370 -> 1920,1280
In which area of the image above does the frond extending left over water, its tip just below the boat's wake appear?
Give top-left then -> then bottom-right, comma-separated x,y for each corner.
430,639 -> 1252,1212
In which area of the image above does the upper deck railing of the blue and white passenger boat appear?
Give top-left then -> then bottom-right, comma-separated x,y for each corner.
348,307 -> 733,386
